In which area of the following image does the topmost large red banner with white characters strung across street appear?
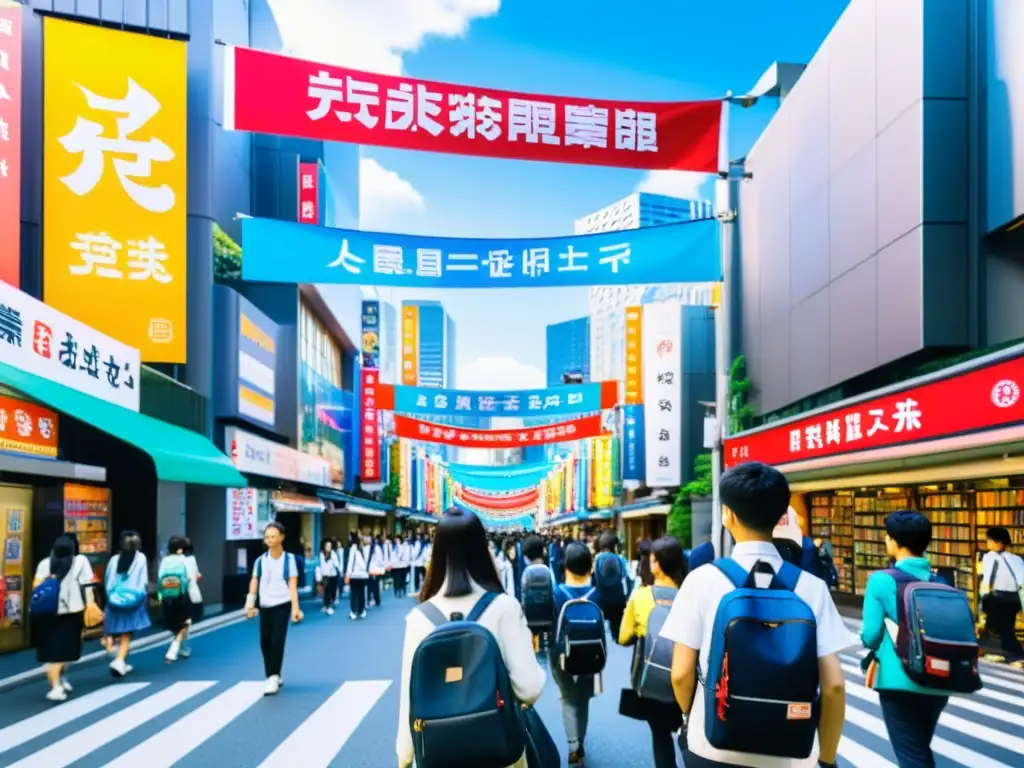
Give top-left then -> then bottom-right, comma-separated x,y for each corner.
224,46 -> 723,173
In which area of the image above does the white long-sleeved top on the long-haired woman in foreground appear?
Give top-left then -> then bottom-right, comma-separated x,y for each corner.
396,584 -> 545,765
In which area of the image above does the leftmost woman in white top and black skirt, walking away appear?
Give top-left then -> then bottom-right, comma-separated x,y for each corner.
33,536 -> 96,701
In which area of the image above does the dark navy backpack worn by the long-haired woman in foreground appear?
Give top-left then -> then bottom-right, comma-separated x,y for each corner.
409,592 -> 526,768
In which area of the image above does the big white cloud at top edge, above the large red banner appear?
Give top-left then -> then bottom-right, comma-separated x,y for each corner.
269,0 -> 501,75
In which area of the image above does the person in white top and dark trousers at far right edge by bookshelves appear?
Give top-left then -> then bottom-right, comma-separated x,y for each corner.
981,526 -> 1024,666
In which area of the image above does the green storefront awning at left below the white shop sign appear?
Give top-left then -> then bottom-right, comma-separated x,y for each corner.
0,362 -> 247,487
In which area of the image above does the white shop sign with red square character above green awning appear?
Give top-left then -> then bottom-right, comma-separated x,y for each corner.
0,282 -> 140,411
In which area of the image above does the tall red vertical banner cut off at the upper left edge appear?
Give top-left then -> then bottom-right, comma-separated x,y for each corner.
0,0 -> 22,288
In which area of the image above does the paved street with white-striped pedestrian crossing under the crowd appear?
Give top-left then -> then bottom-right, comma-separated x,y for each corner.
0,599 -> 1024,768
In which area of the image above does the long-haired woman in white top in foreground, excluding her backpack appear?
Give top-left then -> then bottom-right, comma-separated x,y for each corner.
396,509 -> 545,768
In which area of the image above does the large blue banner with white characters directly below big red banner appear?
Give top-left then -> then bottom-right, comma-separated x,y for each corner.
242,218 -> 722,290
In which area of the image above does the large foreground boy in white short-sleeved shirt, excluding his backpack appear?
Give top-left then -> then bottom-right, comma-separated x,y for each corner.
662,462 -> 859,768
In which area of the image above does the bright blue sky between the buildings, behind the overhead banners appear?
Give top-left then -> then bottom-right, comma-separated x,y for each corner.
272,0 -> 847,386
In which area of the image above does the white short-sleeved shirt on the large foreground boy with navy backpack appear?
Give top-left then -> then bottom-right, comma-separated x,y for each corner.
662,542 -> 860,768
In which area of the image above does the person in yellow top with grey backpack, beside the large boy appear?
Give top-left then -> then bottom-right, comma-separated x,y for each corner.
618,537 -> 686,768
